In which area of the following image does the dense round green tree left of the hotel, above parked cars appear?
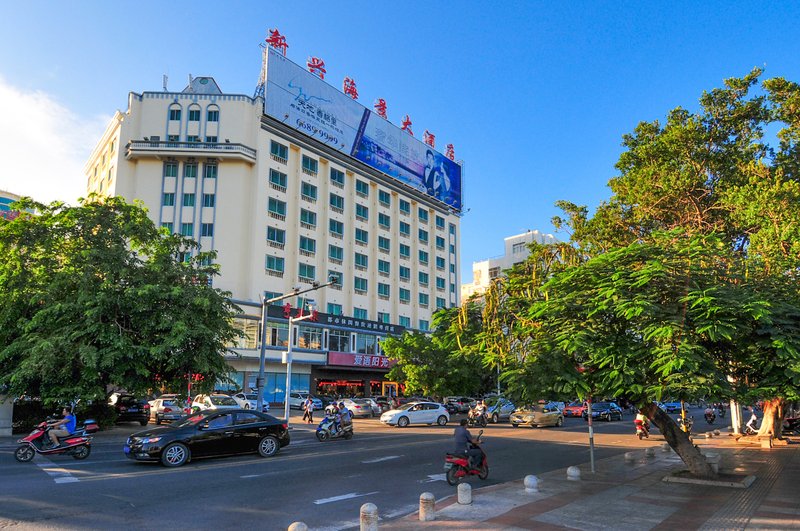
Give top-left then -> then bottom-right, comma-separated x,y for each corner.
0,197 -> 238,401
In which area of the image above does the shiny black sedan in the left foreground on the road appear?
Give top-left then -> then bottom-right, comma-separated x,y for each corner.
124,409 -> 289,467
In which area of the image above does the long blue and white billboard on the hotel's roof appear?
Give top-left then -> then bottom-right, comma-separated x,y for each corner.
264,48 -> 462,211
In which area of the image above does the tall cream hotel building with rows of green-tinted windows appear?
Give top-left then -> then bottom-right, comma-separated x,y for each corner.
85,58 -> 460,402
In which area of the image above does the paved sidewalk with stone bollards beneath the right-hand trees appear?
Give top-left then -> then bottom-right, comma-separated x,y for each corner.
379,436 -> 800,530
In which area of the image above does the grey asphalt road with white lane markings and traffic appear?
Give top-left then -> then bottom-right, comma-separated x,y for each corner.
0,412 -> 721,529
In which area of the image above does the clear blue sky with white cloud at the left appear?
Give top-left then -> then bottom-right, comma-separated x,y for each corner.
0,0 -> 800,282
